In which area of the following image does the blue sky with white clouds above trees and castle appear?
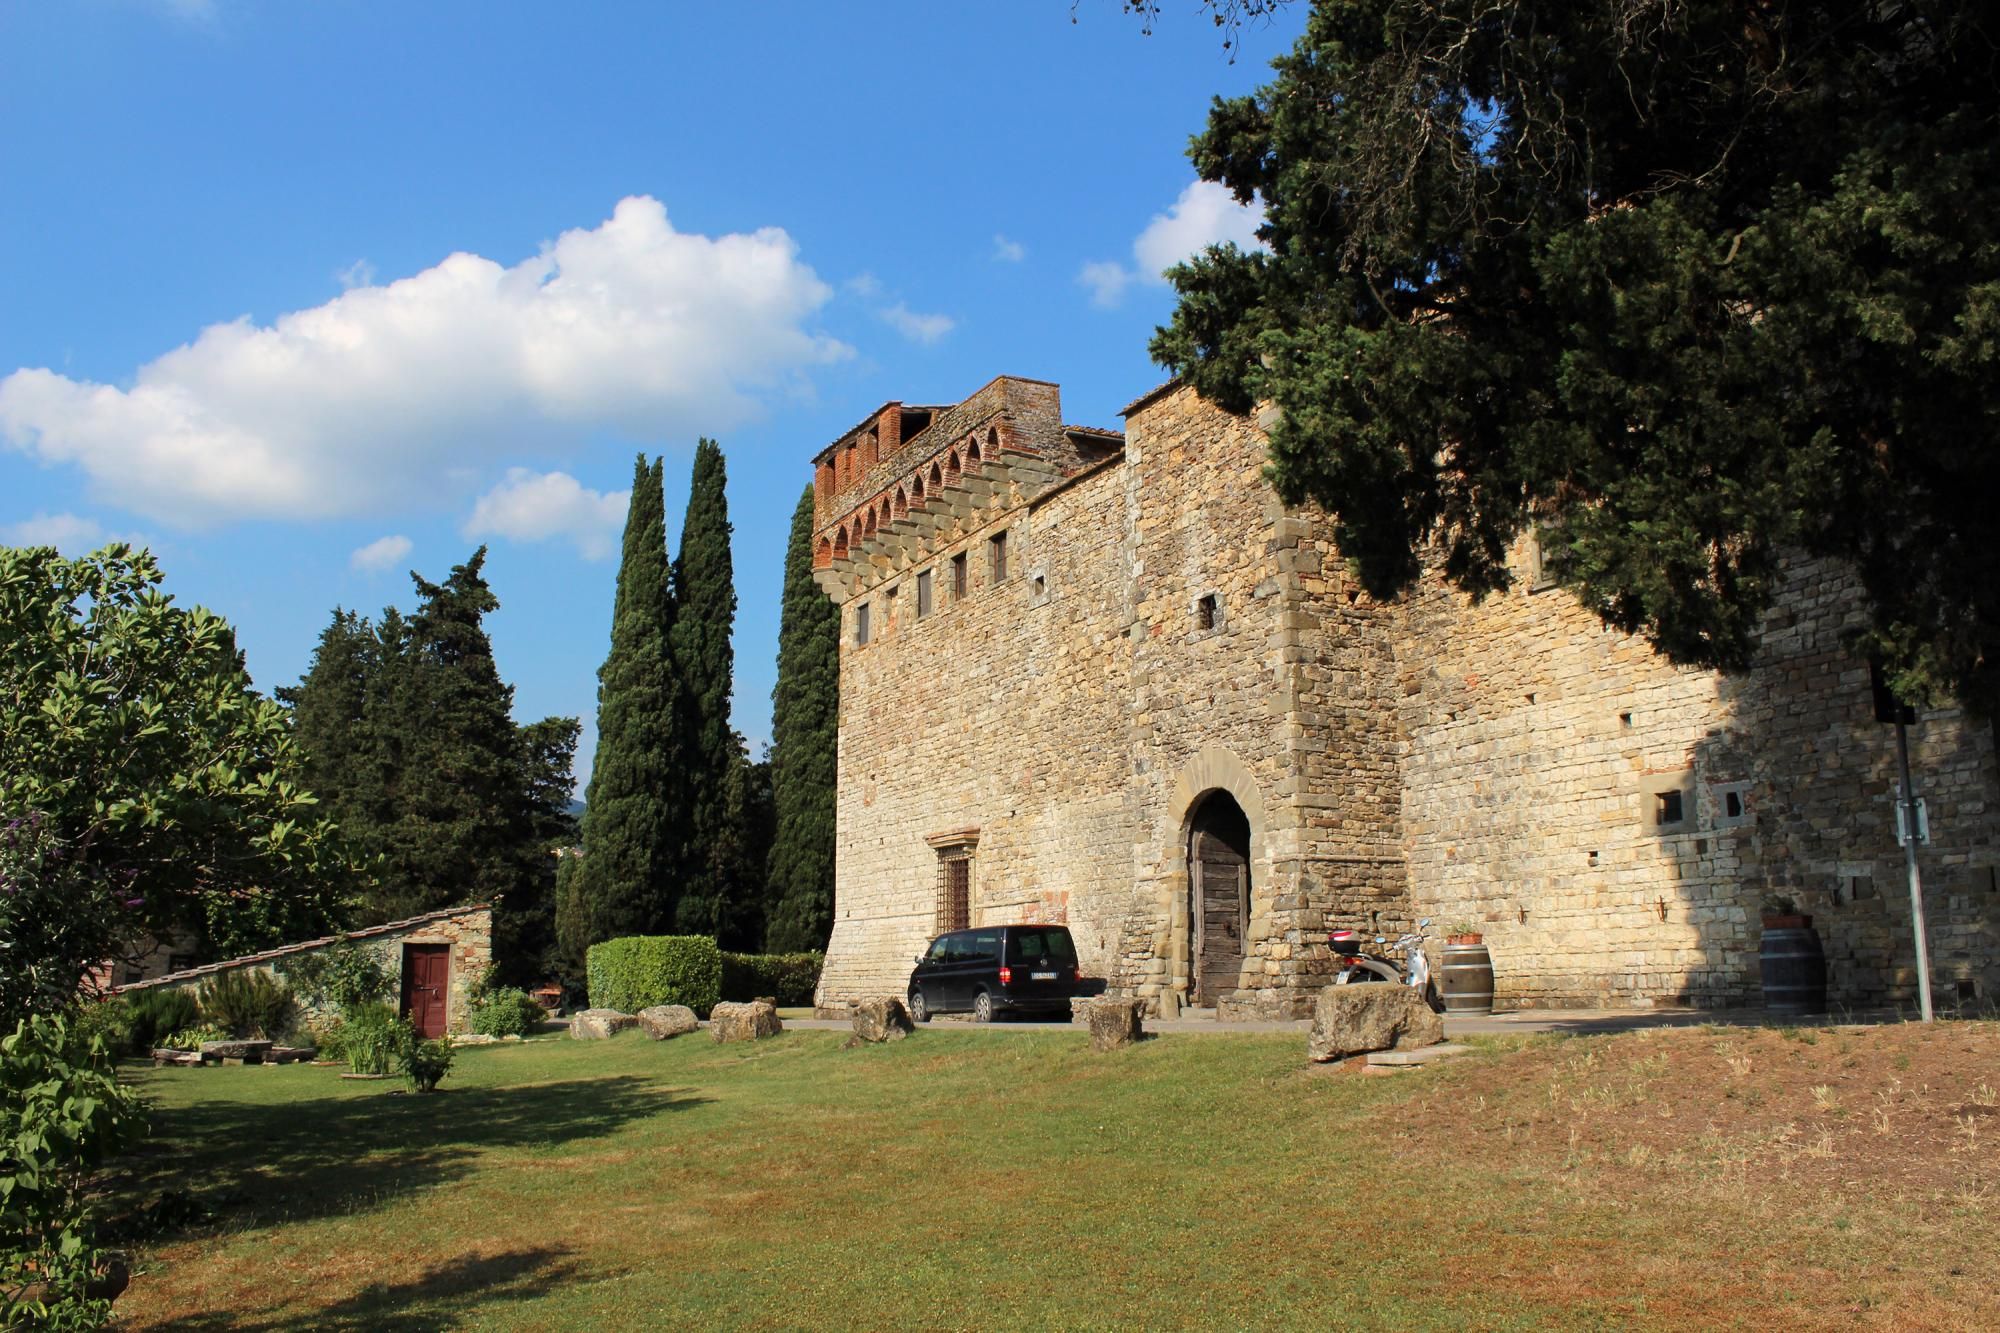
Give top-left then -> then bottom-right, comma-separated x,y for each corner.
0,0 -> 1304,777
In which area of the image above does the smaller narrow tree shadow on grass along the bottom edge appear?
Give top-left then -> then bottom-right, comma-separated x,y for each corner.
150,1249 -> 578,1333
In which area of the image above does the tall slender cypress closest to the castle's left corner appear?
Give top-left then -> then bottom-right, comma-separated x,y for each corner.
764,486 -> 840,953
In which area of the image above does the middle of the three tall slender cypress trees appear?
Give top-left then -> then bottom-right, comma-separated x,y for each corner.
674,438 -> 762,932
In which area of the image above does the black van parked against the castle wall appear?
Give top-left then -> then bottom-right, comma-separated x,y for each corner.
910,925 -> 1084,1023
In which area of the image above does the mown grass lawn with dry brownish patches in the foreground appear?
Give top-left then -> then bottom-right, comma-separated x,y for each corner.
112,1023 -> 2000,1329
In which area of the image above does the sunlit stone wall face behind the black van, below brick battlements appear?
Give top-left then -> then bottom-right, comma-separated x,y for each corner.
818,452 -> 1132,1009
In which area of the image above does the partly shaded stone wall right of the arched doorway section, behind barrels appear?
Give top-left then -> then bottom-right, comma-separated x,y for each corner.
1398,546 -> 2000,1007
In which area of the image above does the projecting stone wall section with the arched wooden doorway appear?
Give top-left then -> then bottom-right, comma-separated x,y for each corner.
1118,386 -> 1404,1015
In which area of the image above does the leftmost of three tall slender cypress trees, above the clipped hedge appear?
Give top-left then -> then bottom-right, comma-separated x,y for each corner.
558,456 -> 688,967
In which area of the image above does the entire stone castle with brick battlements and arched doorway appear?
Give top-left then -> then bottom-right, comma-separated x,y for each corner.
814,376 -> 2000,1015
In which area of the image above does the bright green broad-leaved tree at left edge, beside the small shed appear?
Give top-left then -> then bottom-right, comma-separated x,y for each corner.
0,544 -> 350,1016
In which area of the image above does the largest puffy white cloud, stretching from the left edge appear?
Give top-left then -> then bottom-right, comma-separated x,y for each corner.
0,196 -> 852,524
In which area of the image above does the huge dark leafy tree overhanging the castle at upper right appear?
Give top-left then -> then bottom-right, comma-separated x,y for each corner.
1152,0 -> 2000,715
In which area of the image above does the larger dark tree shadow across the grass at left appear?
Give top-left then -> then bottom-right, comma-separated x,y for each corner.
106,1075 -> 708,1241
